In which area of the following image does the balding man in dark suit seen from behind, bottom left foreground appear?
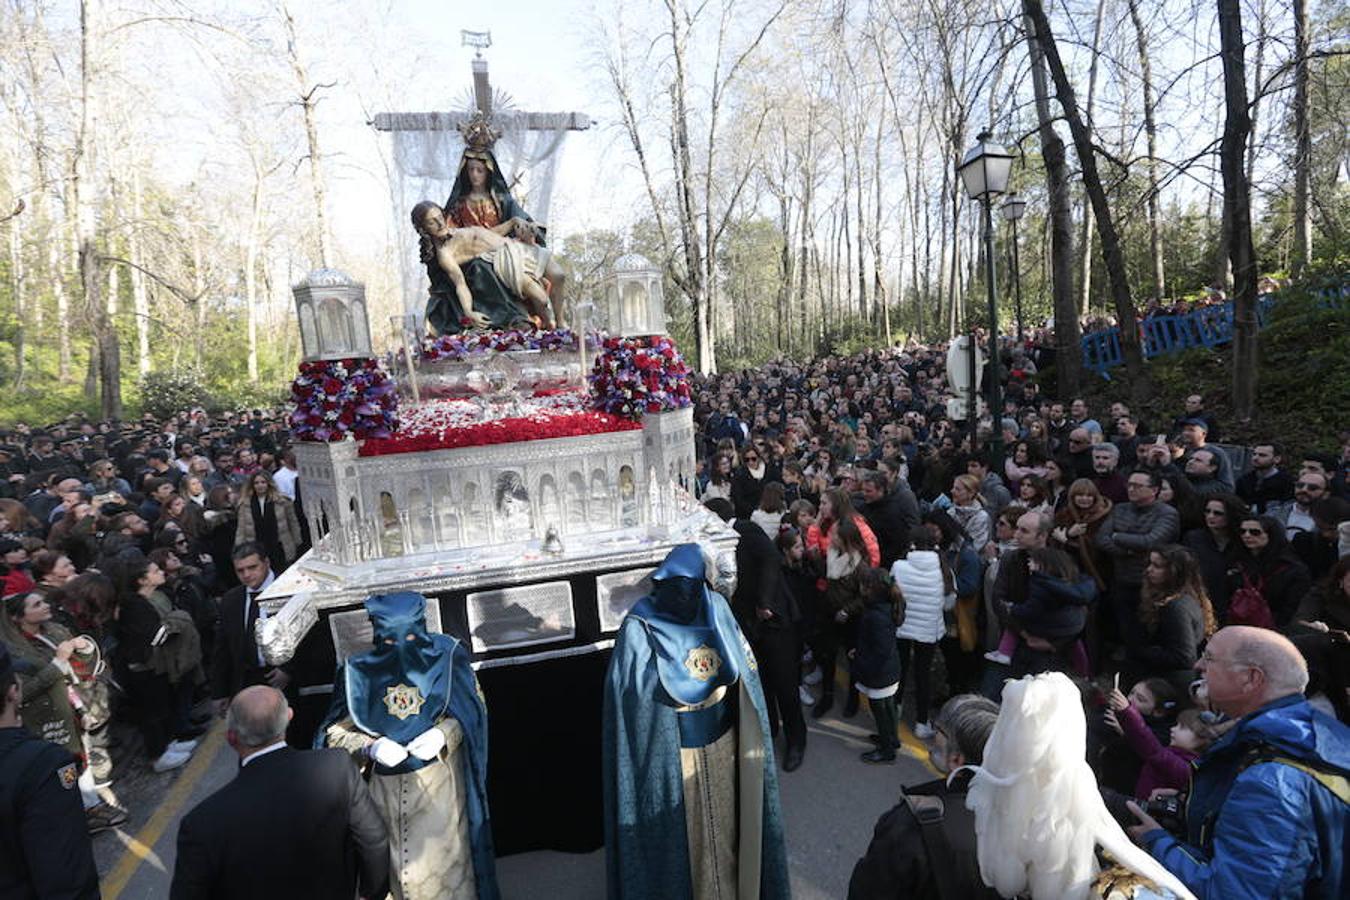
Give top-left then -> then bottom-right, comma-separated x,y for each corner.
169,685 -> 389,900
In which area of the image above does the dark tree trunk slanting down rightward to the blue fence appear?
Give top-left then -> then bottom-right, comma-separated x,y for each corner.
1022,0 -> 1152,403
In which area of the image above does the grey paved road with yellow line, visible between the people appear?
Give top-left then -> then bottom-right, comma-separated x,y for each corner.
95,706 -> 933,900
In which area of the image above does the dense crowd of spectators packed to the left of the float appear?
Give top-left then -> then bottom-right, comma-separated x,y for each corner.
0,410 -> 308,831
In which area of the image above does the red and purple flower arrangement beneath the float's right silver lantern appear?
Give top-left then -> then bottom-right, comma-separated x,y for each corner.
590,335 -> 694,420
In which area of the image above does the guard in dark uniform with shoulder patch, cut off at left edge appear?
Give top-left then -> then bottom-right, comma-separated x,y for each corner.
0,644 -> 99,900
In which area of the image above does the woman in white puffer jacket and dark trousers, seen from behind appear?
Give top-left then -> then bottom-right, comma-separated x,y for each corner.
891,525 -> 956,741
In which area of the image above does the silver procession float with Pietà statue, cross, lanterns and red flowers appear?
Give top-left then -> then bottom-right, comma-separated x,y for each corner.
258,50 -> 736,853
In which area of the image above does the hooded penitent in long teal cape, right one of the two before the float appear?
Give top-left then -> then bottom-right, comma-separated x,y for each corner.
603,544 -> 790,900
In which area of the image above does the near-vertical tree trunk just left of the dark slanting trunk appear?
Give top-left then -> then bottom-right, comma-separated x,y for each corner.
1014,7 -> 1083,397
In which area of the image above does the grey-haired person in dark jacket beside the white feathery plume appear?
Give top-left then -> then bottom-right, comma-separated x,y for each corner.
848,694 -> 999,900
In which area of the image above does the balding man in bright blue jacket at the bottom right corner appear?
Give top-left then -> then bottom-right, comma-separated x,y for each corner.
1130,626 -> 1350,900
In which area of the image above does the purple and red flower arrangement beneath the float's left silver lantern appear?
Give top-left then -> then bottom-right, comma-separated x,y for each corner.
290,359 -> 398,441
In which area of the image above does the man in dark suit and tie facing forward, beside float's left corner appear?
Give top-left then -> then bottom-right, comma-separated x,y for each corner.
211,542 -> 290,715
